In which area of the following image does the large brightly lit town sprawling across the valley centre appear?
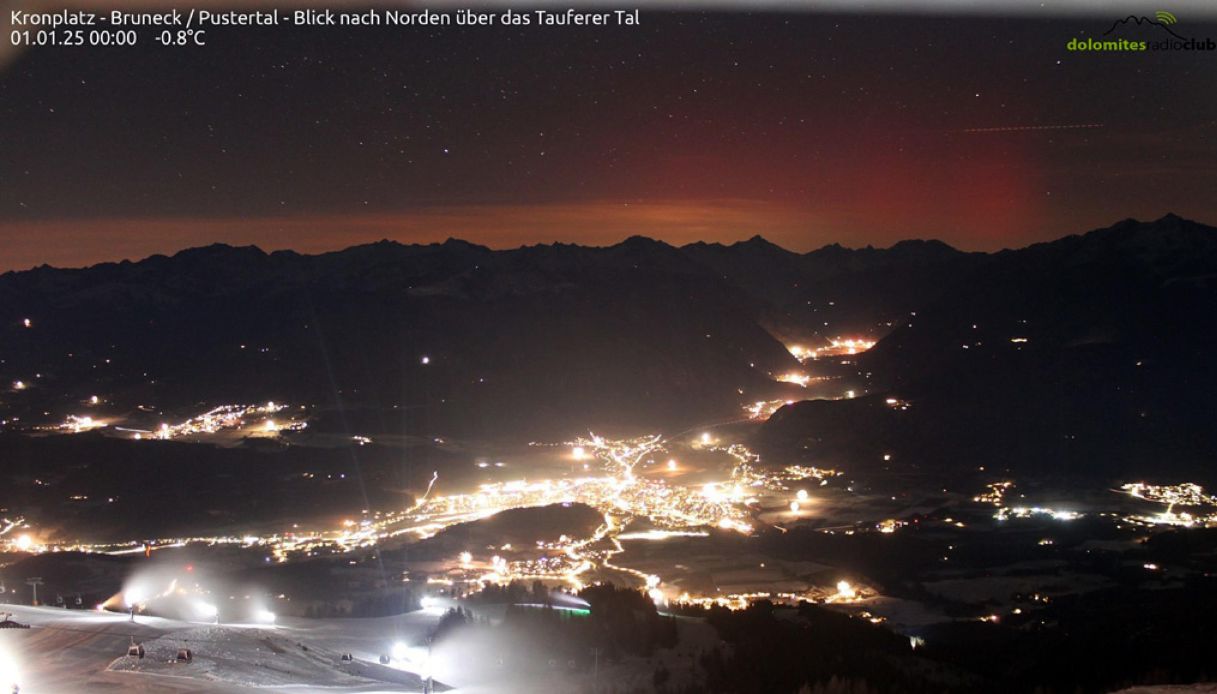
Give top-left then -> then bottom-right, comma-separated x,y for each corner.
0,428 -> 856,606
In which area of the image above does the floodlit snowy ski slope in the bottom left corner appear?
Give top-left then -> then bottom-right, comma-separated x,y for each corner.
0,605 -> 445,694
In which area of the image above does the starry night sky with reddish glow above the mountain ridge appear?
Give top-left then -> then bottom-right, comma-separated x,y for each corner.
0,10 -> 1217,269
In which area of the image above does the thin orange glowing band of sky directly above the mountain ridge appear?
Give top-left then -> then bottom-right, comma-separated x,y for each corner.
0,192 -> 1075,272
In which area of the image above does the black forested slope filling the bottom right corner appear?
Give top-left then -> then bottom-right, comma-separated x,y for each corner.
681,576 -> 1217,694
